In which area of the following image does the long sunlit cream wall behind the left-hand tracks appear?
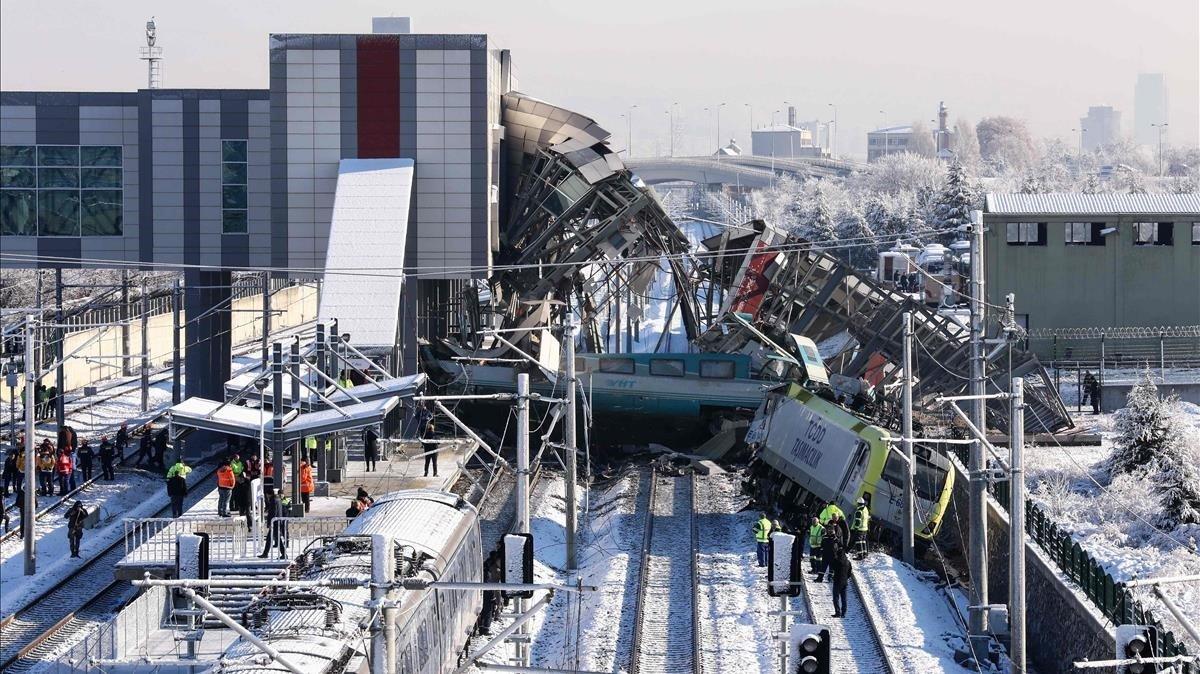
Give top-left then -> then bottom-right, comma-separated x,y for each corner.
0,285 -> 317,403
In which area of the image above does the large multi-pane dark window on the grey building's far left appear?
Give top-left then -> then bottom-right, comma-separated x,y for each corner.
0,145 -> 124,236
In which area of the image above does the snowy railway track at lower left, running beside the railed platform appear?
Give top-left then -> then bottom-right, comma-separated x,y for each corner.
0,467 -> 215,674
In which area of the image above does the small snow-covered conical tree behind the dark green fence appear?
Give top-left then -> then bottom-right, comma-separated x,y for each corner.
1105,371 -> 1175,479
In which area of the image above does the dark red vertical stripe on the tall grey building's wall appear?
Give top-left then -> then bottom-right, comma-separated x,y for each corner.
358,35 -> 400,158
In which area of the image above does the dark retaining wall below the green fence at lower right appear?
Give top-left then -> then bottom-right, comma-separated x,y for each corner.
938,462 -> 1116,674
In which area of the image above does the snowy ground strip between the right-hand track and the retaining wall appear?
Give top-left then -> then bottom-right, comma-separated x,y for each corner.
854,554 -> 968,674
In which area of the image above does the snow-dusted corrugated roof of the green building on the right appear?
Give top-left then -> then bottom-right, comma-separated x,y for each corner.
986,192 -> 1200,216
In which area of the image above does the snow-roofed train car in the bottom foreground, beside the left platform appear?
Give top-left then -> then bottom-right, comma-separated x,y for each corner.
214,489 -> 484,674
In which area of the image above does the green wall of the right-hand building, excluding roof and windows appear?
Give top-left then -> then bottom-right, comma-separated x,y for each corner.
984,213 -> 1200,330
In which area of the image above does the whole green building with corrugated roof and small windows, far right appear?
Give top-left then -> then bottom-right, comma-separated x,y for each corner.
984,193 -> 1200,330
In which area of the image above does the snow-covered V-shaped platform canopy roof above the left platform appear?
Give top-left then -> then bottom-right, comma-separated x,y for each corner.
168,395 -> 401,444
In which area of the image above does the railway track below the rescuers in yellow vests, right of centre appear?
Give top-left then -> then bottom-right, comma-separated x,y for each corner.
800,549 -> 900,674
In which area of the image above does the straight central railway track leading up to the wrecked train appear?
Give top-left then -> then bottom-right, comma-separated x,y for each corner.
629,473 -> 701,674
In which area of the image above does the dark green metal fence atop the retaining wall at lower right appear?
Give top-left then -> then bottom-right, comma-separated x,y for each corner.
979,465 -> 1195,657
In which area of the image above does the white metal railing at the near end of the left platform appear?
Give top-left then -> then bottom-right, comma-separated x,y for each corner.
124,517 -> 253,565
